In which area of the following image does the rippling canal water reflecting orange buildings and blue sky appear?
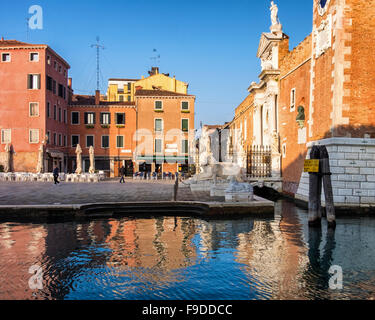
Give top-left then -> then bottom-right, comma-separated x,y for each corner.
0,201 -> 375,300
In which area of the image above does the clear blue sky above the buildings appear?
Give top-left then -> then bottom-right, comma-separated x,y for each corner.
0,0 -> 313,128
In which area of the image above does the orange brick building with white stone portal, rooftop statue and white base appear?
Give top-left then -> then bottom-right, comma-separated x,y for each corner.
227,0 -> 375,206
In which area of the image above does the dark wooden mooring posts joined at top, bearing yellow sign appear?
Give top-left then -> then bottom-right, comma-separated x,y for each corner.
305,146 -> 336,228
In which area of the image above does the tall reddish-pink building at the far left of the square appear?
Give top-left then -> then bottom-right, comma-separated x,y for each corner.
0,38 -> 70,171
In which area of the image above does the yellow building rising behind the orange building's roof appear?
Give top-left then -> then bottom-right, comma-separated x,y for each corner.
107,67 -> 189,102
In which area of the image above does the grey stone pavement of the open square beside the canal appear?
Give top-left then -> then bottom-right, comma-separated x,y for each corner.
0,180 -> 225,205
